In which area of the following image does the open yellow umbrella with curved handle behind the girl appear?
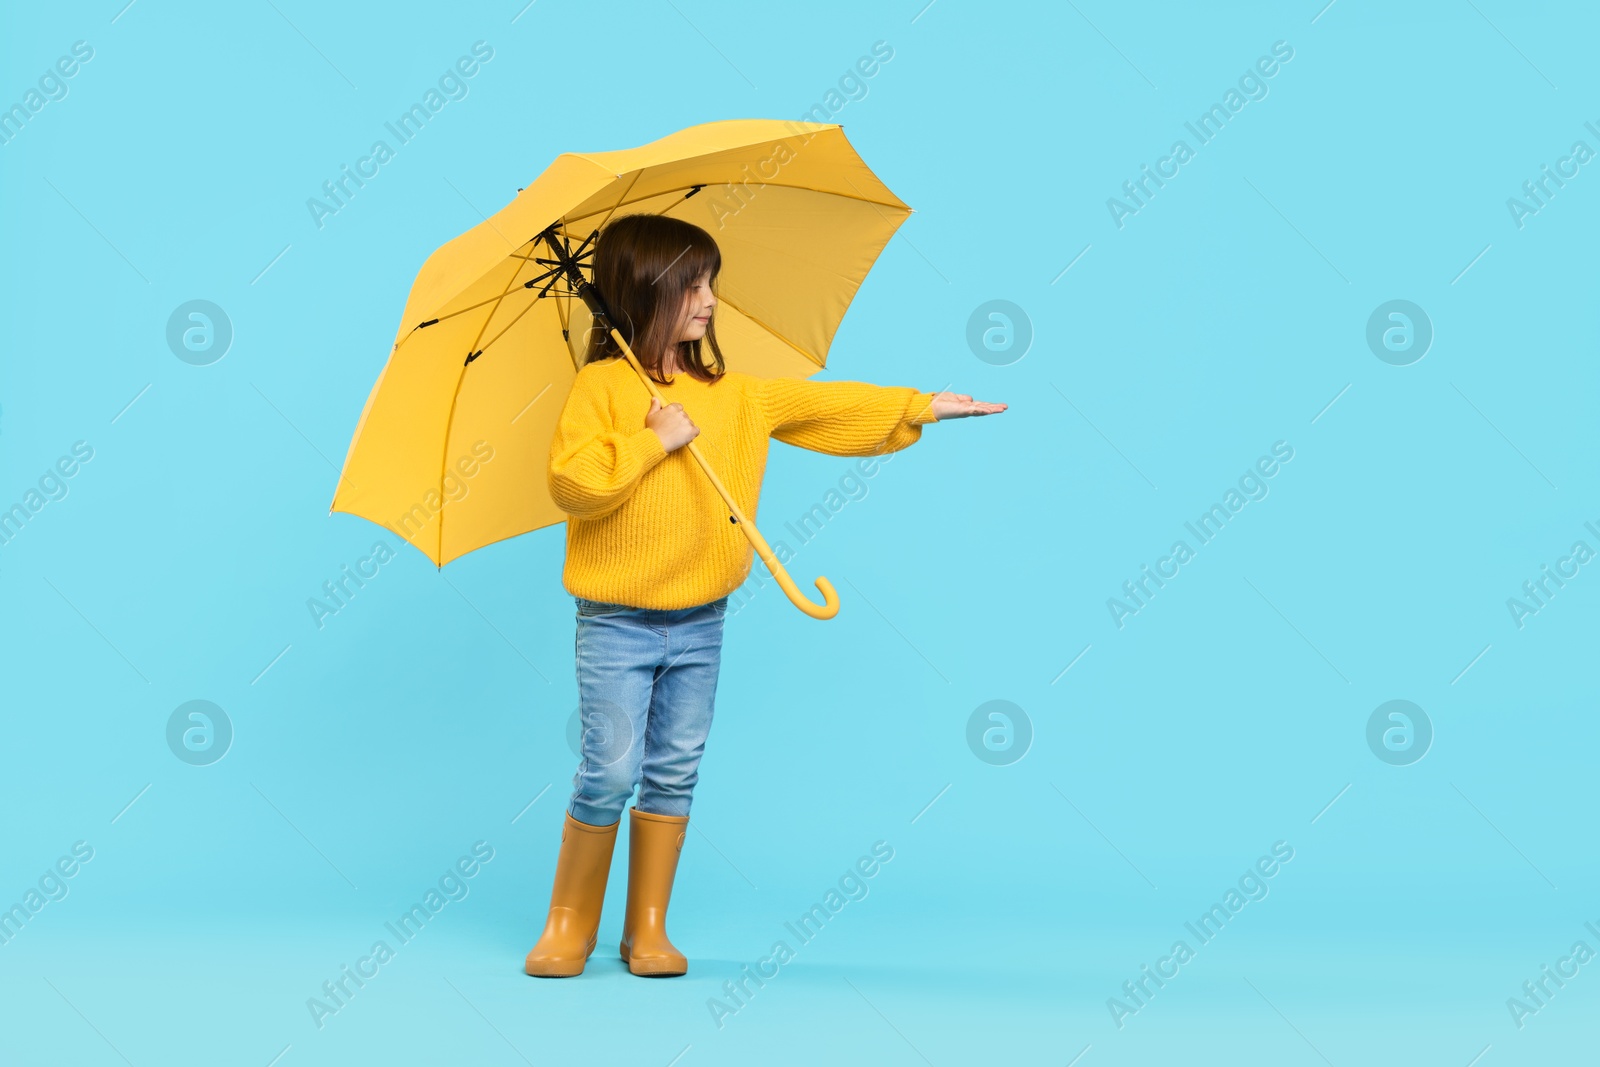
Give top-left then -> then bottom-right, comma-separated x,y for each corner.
330,118 -> 912,619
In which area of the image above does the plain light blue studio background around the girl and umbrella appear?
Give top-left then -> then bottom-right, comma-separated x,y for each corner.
0,0 -> 1600,1067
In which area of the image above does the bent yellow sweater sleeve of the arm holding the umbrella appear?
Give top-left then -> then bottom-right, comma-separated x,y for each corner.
547,373 -> 667,518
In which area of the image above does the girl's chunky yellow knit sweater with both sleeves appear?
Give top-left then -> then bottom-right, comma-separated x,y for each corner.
549,357 -> 938,608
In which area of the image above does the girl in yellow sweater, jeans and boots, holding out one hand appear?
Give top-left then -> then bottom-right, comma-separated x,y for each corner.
523,214 -> 1006,977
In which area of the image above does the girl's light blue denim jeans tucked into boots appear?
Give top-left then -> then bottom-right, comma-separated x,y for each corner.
566,597 -> 728,825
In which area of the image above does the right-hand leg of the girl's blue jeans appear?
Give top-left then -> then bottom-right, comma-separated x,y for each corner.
637,598 -> 726,816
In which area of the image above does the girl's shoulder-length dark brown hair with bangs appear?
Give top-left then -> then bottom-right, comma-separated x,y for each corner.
582,214 -> 726,386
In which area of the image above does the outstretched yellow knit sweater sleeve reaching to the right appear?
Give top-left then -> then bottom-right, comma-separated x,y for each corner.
755,378 -> 939,456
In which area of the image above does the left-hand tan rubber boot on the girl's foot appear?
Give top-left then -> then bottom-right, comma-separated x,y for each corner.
522,813 -> 622,977
